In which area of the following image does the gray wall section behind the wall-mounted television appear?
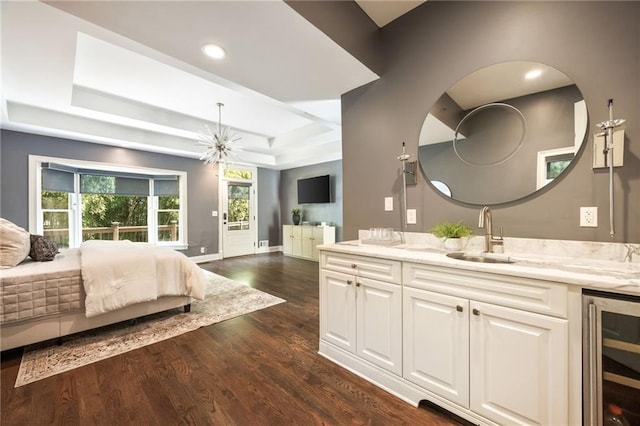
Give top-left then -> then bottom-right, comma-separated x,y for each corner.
280,160 -> 343,241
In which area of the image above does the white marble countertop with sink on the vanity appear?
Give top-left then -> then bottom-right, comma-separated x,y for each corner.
318,240 -> 640,295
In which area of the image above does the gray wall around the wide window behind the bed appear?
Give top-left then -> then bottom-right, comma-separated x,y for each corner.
0,130 -> 218,256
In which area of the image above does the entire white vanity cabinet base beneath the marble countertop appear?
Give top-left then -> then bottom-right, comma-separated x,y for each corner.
319,249 -> 570,425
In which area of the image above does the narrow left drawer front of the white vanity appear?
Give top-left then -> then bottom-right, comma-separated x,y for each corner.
320,251 -> 402,284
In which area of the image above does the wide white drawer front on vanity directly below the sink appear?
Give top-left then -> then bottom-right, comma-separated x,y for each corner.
402,263 -> 568,318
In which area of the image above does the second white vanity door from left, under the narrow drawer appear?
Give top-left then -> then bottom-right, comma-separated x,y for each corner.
356,277 -> 402,376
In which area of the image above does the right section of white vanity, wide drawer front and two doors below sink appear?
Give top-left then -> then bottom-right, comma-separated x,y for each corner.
403,263 -> 569,425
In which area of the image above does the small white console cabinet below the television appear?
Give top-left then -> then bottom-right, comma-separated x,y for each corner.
282,225 -> 336,262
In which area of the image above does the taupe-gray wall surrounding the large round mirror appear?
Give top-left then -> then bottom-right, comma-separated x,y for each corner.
332,1 -> 640,242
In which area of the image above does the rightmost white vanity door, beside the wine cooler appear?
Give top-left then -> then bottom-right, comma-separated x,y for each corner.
470,302 -> 569,425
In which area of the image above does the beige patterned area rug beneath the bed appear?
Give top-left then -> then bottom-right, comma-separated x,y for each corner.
15,271 -> 285,387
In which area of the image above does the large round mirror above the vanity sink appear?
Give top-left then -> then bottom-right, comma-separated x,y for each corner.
418,61 -> 587,205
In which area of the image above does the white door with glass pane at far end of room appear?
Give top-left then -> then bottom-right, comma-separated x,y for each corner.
222,180 -> 256,257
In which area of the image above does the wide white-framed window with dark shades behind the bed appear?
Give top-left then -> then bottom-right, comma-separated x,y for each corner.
30,159 -> 186,248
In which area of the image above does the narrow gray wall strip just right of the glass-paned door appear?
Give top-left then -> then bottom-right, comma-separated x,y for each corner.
258,168 -> 282,246
